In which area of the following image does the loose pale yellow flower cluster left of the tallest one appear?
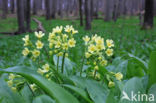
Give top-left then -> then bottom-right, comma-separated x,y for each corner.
22,31 -> 45,59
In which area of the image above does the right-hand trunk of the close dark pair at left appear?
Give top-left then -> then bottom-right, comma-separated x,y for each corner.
25,0 -> 31,31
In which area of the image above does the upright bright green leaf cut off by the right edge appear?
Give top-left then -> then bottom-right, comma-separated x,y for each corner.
148,51 -> 156,87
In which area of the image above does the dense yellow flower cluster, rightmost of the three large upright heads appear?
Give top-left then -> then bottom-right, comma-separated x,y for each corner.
83,34 -> 114,70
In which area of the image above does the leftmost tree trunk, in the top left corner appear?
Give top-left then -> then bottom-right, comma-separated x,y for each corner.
2,0 -> 8,19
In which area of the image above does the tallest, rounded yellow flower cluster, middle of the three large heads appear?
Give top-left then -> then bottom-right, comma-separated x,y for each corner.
48,25 -> 78,56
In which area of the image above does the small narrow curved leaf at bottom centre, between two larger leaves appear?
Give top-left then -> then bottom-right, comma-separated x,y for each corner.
63,84 -> 92,103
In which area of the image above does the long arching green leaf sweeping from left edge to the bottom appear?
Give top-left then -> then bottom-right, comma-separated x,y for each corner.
0,66 -> 79,103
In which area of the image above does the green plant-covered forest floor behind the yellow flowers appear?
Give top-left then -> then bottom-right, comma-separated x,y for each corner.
0,17 -> 156,68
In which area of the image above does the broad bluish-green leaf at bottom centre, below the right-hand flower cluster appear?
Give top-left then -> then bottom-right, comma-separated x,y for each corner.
71,77 -> 109,103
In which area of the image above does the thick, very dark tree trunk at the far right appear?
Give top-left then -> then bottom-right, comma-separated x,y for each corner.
143,0 -> 154,29
